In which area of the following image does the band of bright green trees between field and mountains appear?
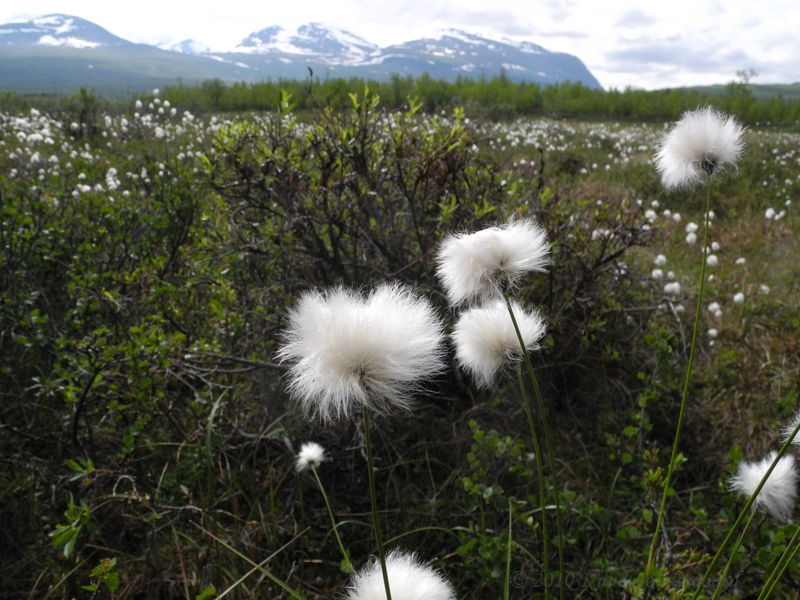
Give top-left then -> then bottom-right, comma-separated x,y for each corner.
152,75 -> 800,126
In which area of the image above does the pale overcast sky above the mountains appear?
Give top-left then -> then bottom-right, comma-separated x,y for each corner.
0,0 -> 800,89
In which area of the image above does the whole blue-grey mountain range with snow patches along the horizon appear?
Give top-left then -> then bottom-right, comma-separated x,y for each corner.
0,14 -> 600,95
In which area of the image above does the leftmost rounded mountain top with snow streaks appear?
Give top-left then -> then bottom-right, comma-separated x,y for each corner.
0,14 -> 134,48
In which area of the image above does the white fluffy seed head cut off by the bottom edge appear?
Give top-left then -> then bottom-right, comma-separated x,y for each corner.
345,551 -> 456,600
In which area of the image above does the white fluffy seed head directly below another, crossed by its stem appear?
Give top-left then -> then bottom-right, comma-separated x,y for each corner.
453,300 -> 546,388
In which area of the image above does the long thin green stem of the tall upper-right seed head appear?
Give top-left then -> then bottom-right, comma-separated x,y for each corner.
644,188 -> 711,590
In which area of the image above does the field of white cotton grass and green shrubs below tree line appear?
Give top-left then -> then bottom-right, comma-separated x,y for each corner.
0,91 -> 800,600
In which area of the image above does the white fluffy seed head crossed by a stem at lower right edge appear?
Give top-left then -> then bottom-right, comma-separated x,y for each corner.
731,450 -> 797,522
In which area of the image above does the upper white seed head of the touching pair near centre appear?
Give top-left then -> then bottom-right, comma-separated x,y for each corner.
436,219 -> 550,305
